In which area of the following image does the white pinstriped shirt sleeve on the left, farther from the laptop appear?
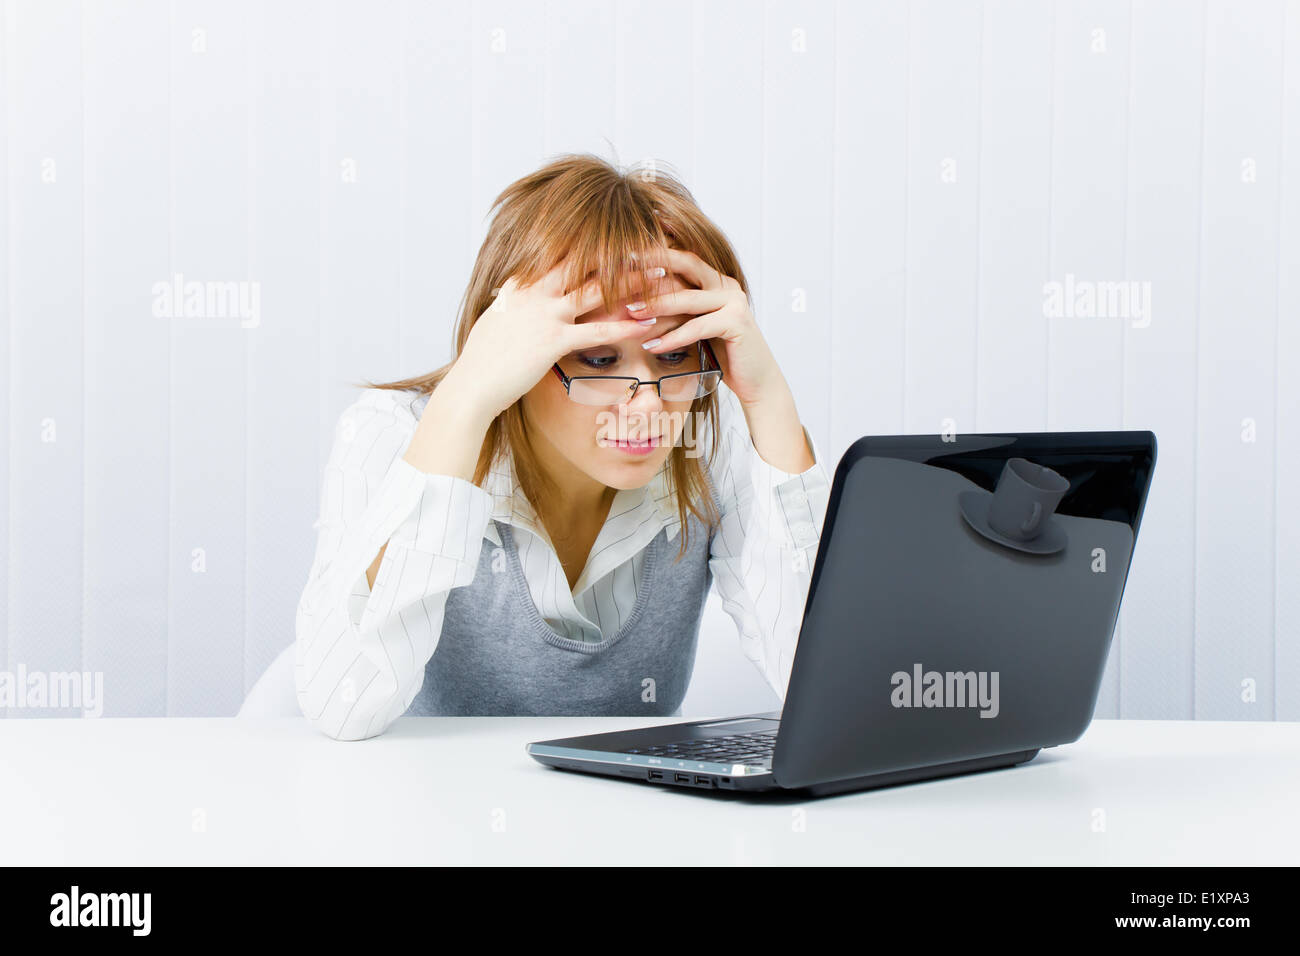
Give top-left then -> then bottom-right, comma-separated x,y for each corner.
294,389 -> 491,740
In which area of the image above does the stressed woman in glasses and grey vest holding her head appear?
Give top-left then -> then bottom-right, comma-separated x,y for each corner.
295,156 -> 829,740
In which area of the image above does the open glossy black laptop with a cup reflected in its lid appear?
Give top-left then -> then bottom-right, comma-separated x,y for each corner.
527,431 -> 1156,796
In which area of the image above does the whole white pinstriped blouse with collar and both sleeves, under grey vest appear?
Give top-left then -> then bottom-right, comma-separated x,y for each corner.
295,385 -> 829,740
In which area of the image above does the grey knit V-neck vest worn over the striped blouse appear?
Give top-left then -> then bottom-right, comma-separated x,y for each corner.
406,497 -> 716,717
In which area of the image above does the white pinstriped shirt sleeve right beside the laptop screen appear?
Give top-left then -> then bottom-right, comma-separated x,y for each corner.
709,389 -> 831,701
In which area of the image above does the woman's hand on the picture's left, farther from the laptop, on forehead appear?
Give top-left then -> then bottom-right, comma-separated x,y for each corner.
449,261 -> 657,420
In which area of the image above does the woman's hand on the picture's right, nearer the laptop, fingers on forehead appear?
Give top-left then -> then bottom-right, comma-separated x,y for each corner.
628,248 -> 789,407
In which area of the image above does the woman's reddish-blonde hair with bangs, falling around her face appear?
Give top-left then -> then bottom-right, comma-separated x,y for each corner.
361,153 -> 749,559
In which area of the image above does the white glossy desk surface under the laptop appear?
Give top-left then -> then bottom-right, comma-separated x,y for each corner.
0,717 -> 1300,866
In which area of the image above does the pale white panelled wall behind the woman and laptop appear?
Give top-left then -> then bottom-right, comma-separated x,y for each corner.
0,0 -> 1300,719
